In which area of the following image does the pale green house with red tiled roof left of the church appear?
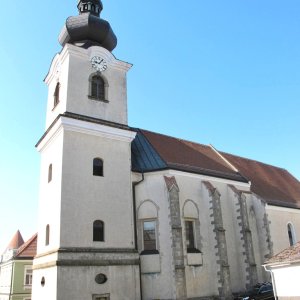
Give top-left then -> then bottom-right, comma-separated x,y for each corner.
0,231 -> 37,300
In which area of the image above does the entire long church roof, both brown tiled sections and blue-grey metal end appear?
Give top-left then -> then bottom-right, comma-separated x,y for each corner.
132,129 -> 300,208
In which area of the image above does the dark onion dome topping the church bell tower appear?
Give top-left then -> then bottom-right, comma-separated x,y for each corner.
58,0 -> 117,51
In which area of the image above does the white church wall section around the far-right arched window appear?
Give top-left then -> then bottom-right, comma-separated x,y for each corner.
266,205 -> 300,254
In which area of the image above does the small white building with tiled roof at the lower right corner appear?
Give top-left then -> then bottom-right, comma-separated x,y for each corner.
264,242 -> 300,300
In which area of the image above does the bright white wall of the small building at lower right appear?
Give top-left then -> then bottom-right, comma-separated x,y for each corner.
271,262 -> 300,299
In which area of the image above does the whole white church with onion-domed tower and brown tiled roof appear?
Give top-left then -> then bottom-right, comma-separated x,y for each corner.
32,0 -> 300,300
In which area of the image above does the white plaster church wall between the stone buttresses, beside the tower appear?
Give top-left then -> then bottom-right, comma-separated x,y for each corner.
136,171 -> 254,299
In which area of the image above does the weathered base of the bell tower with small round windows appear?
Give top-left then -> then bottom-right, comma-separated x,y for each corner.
32,249 -> 141,300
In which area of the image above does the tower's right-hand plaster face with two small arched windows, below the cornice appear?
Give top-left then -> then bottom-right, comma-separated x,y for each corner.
61,131 -> 134,248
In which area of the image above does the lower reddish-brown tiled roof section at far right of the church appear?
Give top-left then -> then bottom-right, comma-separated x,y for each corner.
220,152 -> 300,208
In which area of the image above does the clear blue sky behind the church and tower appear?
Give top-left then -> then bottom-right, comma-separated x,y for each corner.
0,0 -> 300,251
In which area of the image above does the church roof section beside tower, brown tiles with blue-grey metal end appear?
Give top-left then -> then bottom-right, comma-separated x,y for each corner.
132,130 -> 247,182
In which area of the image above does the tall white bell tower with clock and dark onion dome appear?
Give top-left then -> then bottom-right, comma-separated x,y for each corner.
32,0 -> 140,300
